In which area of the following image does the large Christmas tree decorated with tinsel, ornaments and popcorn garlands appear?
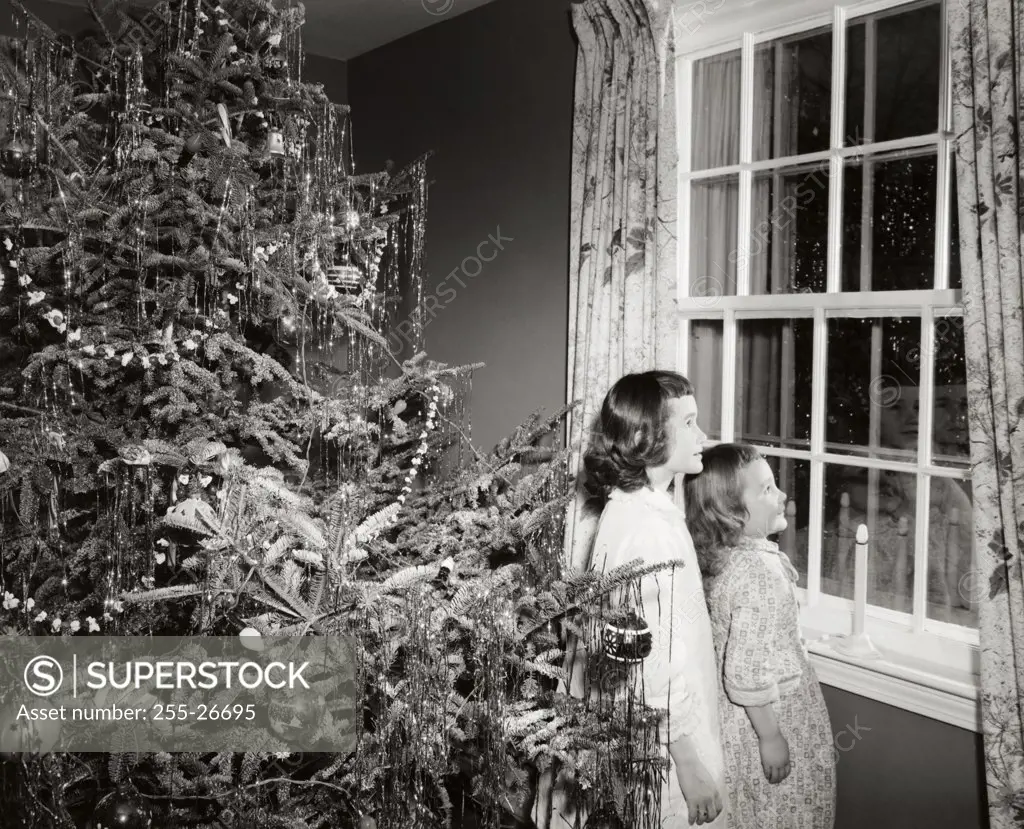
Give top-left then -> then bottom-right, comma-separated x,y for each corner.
0,0 -> 660,829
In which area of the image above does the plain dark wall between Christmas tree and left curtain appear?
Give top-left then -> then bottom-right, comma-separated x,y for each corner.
348,0 -> 575,456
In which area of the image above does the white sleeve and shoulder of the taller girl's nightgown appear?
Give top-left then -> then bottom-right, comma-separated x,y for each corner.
608,518 -> 712,743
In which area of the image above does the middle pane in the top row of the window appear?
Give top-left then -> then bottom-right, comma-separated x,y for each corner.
754,28 -> 831,161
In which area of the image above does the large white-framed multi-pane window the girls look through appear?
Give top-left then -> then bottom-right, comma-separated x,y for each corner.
678,0 -> 982,727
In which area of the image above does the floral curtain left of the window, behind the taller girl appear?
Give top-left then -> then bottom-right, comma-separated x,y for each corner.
565,0 -> 677,568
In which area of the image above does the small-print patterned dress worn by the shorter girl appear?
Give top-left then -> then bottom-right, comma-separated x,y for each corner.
708,538 -> 836,829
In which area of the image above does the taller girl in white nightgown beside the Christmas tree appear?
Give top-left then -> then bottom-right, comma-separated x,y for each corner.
550,372 -> 727,829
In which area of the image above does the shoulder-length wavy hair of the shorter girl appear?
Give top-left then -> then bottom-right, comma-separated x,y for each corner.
683,443 -> 764,578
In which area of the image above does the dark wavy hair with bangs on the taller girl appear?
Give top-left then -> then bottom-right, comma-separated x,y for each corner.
584,372 -> 693,500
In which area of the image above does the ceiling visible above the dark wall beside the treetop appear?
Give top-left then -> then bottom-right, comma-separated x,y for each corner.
48,0 -> 503,60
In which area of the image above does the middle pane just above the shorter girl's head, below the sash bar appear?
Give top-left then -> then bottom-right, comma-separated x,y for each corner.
736,319 -> 814,449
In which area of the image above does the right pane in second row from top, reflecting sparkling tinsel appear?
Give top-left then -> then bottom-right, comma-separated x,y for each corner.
842,154 -> 936,291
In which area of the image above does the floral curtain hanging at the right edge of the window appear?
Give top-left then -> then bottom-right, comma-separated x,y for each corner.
947,0 -> 1024,829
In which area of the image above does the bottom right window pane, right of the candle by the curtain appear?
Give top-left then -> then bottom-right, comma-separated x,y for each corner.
927,478 -> 974,627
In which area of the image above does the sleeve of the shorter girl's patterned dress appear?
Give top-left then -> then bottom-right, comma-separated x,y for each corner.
722,556 -> 781,706
